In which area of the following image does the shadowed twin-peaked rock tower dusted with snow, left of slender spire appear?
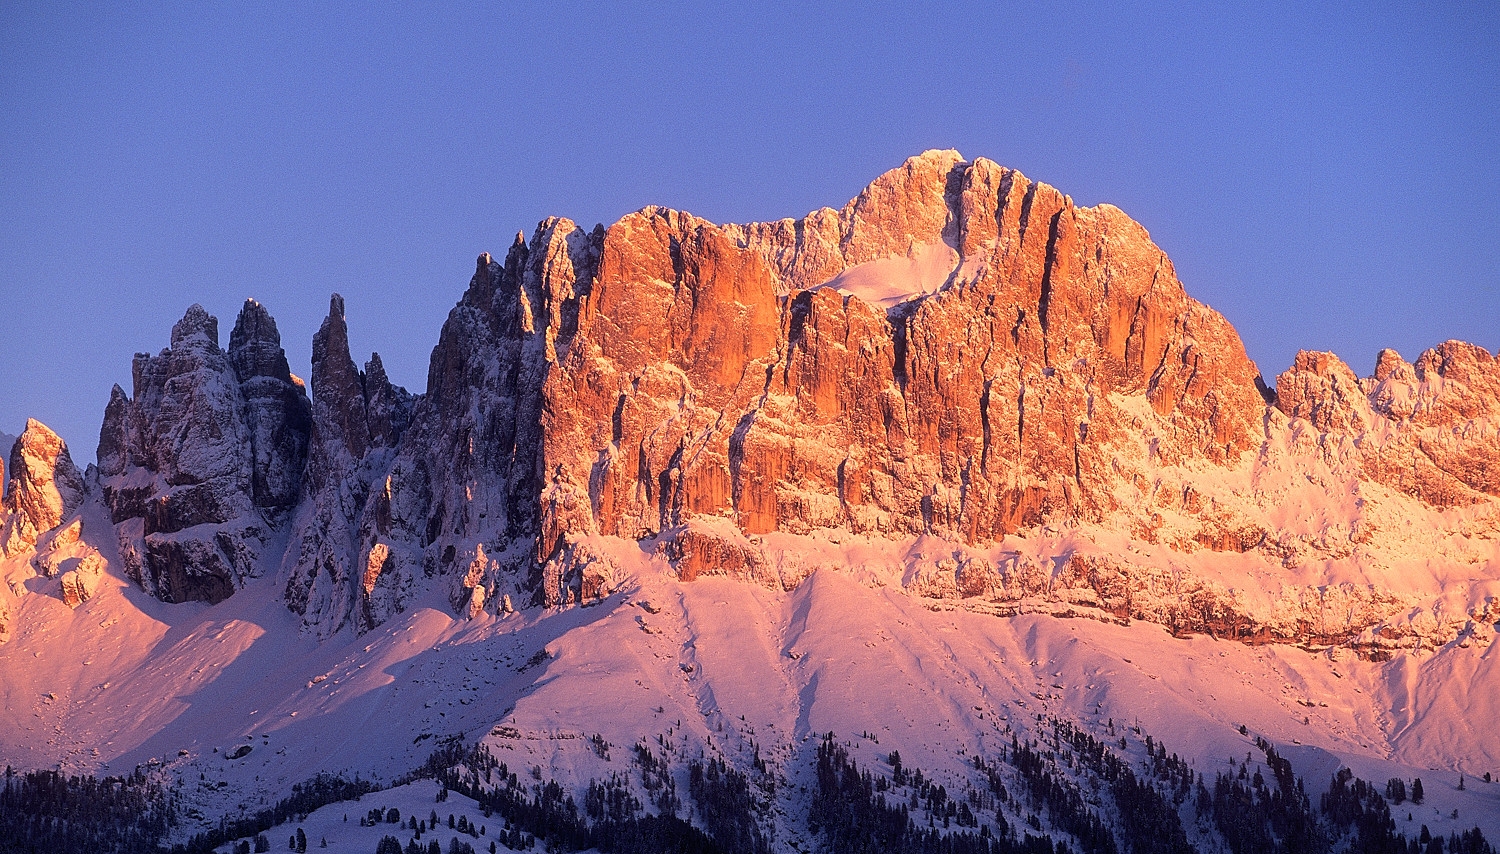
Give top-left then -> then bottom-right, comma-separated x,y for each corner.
99,300 -> 311,602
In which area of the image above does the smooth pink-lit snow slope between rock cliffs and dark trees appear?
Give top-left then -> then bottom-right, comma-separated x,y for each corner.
0,539 -> 1500,843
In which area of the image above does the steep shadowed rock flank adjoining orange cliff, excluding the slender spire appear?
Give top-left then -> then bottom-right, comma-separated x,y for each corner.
362,219 -> 603,618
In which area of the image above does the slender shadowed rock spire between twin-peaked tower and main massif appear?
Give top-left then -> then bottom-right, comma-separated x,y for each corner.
285,294 -> 413,635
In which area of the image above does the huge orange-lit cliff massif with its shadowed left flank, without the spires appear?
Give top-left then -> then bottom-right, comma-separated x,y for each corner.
258,152 -> 1500,650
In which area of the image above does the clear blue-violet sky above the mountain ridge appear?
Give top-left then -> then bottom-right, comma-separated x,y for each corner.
0,0 -> 1500,462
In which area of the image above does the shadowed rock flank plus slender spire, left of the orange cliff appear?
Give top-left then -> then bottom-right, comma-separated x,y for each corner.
287,219 -> 603,635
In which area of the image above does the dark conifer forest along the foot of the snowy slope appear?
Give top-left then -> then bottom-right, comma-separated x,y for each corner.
0,716 -> 1496,854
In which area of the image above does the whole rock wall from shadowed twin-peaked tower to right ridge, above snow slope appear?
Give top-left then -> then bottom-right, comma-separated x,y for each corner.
85,152 -> 1500,653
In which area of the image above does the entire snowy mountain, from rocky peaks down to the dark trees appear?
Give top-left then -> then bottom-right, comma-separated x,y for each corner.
0,152 -> 1500,849
